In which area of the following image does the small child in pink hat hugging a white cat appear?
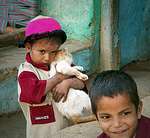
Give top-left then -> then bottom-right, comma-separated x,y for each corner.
18,16 -> 84,138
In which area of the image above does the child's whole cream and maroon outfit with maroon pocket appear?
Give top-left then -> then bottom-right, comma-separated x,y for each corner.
18,53 -> 68,138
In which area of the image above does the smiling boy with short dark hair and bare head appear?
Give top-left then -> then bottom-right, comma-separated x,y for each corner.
90,70 -> 150,138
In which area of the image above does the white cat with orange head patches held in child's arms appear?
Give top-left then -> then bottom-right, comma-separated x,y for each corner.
49,49 -> 92,122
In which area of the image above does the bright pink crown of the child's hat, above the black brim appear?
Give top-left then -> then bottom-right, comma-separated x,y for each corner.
25,16 -> 61,37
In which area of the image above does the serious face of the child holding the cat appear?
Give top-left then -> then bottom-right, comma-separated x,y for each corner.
26,39 -> 60,65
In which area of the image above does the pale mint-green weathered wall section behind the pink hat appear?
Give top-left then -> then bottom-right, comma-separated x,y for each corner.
41,0 -> 94,41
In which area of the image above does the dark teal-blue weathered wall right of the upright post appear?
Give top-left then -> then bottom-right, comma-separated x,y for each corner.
119,0 -> 150,66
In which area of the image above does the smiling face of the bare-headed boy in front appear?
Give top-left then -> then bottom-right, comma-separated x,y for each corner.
97,94 -> 141,138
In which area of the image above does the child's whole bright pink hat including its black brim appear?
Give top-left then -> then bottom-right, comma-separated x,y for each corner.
25,15 -> 67,43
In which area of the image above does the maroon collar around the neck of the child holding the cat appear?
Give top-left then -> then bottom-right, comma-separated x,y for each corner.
26,53 -> 49,71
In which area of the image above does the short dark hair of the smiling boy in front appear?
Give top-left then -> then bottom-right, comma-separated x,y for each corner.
90,70 -> 140,115
